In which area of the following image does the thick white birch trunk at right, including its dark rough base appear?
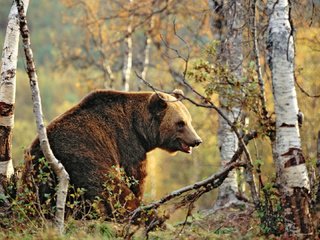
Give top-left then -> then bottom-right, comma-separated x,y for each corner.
267,0 -> 313,238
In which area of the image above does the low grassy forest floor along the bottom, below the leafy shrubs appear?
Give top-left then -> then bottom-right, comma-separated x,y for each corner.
0,205 -> 276,240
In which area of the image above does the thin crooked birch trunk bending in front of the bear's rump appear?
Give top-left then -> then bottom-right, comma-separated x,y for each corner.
16,0 -> 69,234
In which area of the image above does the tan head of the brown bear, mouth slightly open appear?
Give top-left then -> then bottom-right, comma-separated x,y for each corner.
149,90 -> 202,153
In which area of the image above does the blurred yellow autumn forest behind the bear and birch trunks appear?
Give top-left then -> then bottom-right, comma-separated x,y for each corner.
0,0 -> 320,222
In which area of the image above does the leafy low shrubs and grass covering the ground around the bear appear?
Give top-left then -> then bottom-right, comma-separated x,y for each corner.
0,159 -> 275,240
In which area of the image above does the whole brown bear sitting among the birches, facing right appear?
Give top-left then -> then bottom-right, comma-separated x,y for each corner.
30,90 -> 202,219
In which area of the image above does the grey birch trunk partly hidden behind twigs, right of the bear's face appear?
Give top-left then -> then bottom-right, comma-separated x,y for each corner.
209,0 -> 243,209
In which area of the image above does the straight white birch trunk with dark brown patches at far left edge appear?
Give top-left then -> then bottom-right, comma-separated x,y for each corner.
0,0 -> 29,178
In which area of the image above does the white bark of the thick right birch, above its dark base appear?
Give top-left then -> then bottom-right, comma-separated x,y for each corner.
268,0 -> 309,194
